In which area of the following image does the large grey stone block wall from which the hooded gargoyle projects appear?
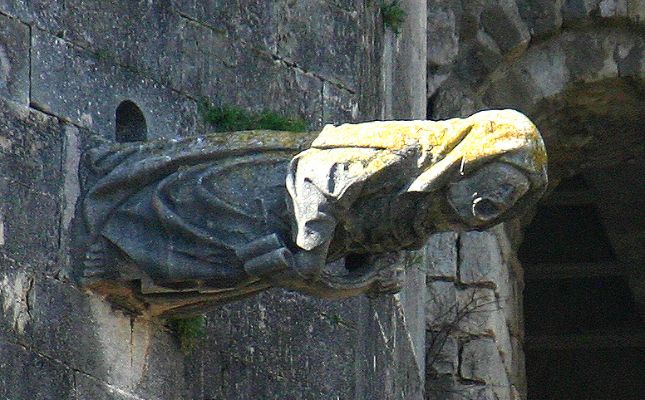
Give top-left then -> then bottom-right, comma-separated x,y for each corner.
0,0 -> 426,400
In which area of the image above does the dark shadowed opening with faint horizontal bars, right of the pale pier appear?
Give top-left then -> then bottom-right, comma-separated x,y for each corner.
518,173 -> 645,400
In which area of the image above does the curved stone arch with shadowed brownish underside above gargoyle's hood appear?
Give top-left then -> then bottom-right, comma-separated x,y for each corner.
433,27 -> 645,177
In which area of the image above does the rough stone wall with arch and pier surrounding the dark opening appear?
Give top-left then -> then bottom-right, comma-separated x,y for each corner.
427,0 -> 645,399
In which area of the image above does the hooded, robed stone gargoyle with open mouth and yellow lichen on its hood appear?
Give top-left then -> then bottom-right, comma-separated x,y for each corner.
77,110 -> 547,315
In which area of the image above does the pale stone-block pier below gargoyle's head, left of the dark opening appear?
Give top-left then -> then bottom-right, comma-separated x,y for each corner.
426,224 -> 526,400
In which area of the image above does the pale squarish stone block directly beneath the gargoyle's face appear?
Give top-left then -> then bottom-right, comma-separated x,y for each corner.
459,231 -> 507,286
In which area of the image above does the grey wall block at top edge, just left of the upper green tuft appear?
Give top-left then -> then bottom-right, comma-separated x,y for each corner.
275,0 -> 361,90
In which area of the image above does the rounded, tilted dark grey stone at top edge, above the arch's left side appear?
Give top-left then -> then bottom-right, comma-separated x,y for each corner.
481,2 -> 531,57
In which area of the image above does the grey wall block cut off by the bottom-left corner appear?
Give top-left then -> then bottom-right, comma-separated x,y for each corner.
0,342 -> 74,400
